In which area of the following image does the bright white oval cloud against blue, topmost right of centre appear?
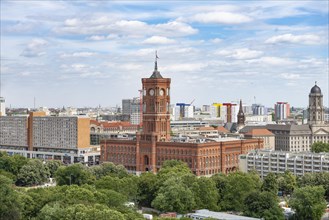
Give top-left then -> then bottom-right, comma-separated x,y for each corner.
189,12 -> 253,24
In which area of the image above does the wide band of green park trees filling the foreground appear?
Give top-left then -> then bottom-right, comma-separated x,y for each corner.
0,153 -> 329,220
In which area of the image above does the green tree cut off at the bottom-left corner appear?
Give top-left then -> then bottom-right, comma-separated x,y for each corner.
0,175 -> 20,220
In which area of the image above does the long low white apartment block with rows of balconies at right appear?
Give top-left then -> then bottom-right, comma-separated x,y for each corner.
239,150 -> 329,178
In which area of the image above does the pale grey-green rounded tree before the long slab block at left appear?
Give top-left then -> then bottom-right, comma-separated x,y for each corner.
16,159 -> 50,186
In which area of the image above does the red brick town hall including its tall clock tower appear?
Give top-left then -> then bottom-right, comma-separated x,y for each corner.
101,57 -> 263,176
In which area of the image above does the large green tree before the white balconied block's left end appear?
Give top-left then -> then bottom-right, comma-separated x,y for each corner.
219,172 -> 261,211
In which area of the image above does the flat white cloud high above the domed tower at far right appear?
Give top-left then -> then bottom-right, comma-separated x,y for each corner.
265,34 -> 322,44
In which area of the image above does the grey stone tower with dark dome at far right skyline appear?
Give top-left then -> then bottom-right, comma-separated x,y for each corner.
308,82 -> 324,125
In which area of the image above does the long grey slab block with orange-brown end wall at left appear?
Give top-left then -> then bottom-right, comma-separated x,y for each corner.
0,112 -> 90,163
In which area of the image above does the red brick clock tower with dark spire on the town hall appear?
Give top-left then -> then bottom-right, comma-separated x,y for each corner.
136,52 -> 171,173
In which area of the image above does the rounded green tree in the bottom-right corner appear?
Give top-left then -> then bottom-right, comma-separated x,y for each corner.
289,186 -> 326,220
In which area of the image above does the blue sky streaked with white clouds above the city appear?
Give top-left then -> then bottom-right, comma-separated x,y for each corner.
0,0 -> 329,107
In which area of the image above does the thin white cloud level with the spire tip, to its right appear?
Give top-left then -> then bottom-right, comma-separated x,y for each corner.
215,48 -> 263,60
